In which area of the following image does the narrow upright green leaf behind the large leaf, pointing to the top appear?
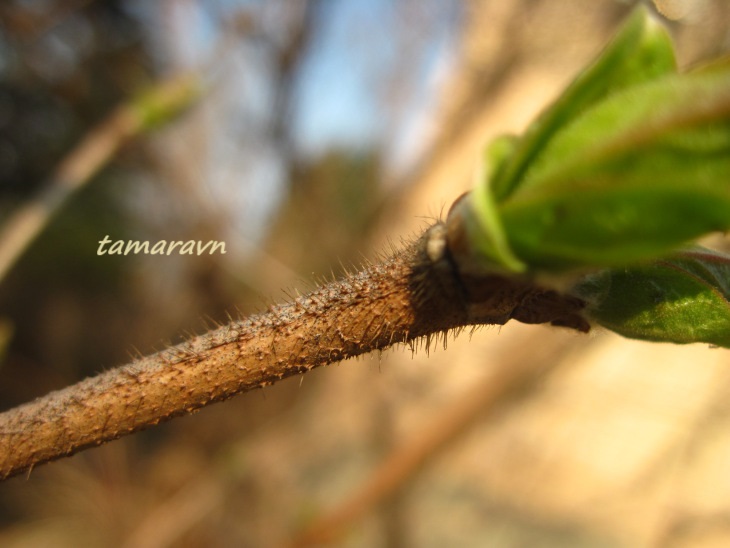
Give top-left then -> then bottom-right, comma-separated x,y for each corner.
490,6 -> 676,201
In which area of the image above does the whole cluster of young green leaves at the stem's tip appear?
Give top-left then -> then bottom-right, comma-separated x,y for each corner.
447,7 -> 730,346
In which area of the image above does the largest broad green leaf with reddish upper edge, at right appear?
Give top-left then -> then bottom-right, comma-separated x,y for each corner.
499,63 -> 730,270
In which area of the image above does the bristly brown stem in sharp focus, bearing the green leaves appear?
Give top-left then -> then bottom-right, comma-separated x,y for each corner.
0,224 -> 587,479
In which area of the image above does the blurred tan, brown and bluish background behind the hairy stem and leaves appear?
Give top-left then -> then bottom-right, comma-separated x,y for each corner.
0,0 -> 730,547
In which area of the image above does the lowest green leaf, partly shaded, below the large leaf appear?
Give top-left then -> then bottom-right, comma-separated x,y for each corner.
576,249 -> 730,348
